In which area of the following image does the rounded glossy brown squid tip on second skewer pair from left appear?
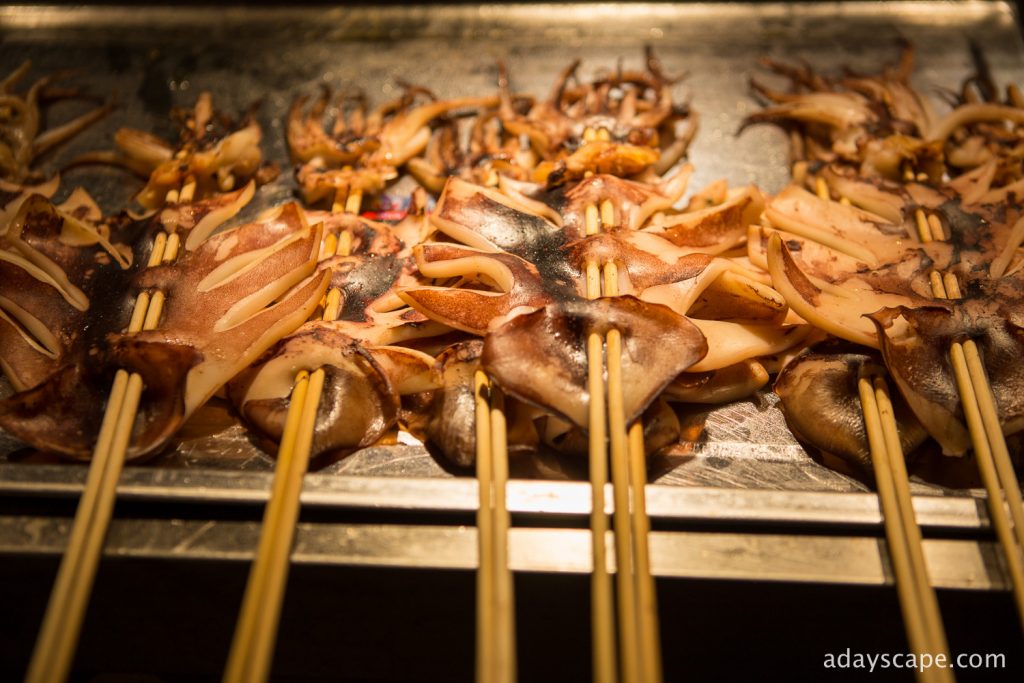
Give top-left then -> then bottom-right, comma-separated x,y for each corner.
227,323 -> 399,456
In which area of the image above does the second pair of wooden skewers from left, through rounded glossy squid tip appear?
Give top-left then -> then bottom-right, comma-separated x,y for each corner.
223,188 -> 361,683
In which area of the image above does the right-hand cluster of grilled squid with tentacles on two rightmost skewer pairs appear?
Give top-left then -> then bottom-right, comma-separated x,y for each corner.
748,48 -> 1024,475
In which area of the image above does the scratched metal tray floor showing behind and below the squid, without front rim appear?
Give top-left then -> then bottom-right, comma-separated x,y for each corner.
0,1 -> 1024,493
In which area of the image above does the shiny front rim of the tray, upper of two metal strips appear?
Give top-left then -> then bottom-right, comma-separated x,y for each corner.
0,464 -> 988,530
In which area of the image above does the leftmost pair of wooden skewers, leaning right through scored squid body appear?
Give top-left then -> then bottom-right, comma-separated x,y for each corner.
25,182 -> 195,683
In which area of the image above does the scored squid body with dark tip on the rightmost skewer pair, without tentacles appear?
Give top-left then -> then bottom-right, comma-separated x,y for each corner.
766,172 -> 1024,455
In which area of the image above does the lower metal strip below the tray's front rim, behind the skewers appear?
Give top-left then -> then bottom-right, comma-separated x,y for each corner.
0,517 -> 1008,590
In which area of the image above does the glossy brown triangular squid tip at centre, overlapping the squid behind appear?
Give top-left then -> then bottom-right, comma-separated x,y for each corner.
481,296 -> 708,429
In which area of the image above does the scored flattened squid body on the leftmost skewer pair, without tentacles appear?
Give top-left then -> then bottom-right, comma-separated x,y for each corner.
0,172 -> 327,458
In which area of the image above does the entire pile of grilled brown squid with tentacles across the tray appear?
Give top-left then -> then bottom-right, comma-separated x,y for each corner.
0,47 -> 1024,485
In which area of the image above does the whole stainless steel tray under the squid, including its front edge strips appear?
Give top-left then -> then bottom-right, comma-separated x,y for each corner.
0,1 -> 1024,587
